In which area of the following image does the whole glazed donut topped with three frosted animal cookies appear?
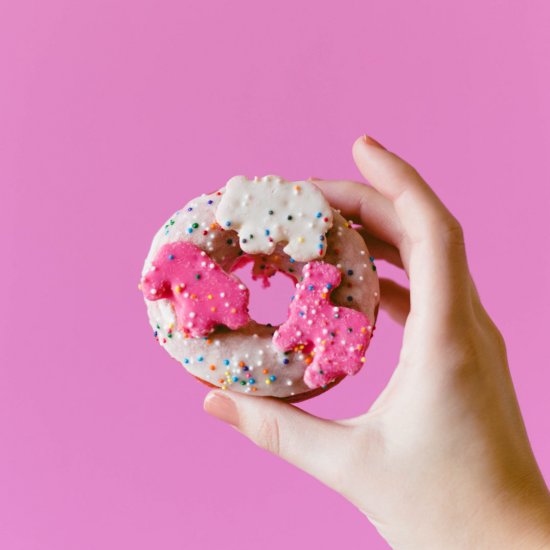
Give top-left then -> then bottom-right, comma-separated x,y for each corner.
139,176 -> 380,402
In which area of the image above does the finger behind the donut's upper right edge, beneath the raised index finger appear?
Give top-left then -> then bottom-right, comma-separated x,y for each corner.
313,179 -> 402,250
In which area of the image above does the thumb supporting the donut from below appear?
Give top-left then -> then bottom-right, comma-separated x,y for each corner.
204,390 -> 352,491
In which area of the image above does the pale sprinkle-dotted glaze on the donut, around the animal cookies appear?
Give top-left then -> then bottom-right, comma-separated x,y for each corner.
142,179 -> 379,399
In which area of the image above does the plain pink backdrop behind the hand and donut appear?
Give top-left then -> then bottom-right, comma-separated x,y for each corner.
0,0 -> 550,550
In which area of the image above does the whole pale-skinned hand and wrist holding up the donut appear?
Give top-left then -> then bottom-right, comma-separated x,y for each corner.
205,136 -> 550,550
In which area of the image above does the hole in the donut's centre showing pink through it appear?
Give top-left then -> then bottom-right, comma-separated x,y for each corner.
234,263 -> 302,326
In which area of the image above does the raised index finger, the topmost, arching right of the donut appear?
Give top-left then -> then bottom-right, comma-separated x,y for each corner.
353,138 -> 469,323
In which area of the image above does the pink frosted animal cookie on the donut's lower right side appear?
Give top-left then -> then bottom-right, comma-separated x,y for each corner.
273,262 -> 372,389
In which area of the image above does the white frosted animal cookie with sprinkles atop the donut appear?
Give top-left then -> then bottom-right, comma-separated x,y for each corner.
216,176 -> 332,262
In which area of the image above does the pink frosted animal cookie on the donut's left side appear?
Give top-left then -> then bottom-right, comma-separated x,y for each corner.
141,241 -> 250,338
